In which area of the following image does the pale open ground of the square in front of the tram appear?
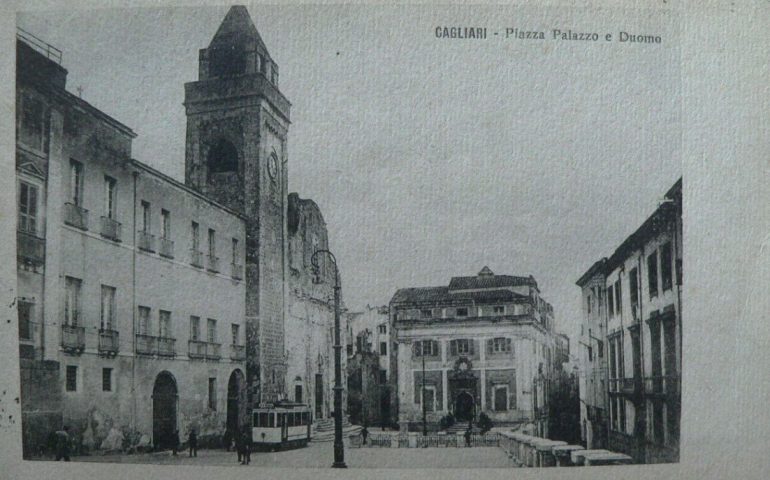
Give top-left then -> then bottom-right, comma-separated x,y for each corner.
52,442 -> 513,469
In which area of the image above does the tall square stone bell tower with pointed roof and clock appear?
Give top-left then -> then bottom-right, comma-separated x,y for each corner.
184,6 -> 291,405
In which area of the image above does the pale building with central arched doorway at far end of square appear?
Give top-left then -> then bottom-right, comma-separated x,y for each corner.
390,267 -> 555,436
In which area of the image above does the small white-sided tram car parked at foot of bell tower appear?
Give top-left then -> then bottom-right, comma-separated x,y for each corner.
251,402 -> 312,451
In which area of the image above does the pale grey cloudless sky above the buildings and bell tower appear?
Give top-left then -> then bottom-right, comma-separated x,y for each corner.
18,5 -> 682,342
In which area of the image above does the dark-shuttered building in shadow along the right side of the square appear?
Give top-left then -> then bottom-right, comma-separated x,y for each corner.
578,179 -> 682,463
